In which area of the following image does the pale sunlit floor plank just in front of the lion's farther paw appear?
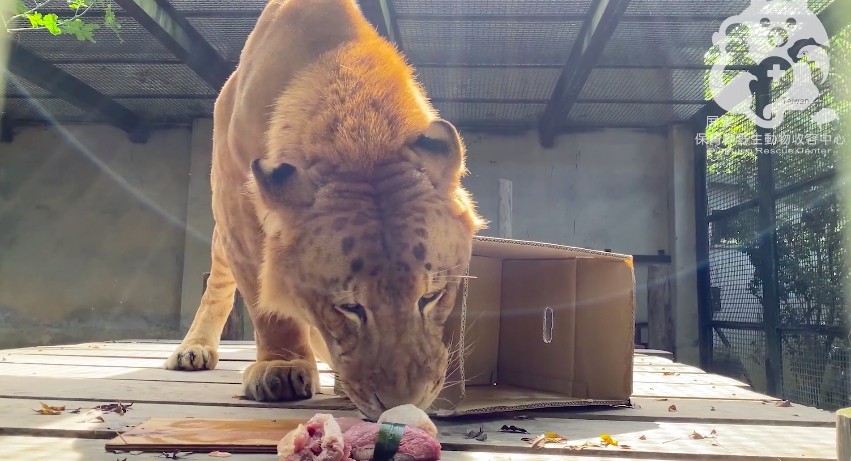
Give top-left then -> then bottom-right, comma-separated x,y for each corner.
0,362 -> 334,393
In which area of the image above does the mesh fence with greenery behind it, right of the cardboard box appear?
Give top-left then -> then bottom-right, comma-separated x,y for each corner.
698,19 -> 851,410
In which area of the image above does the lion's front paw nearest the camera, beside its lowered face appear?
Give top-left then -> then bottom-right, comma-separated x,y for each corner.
242,360 -> 319,401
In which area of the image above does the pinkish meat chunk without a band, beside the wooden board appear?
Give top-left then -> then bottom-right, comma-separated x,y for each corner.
278,413 -> 351,461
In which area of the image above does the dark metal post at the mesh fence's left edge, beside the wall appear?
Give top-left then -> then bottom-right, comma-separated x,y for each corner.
694,120 -> 712,370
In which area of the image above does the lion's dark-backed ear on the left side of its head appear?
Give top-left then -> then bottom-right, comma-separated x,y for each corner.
251,159 -> 316,207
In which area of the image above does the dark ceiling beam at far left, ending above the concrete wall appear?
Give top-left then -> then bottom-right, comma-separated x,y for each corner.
8,43 -> 150,143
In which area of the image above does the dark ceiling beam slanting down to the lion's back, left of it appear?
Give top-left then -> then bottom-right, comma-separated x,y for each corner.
115,0 -> 233,92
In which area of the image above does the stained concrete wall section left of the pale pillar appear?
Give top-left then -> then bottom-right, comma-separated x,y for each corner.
0,126 -> 190,347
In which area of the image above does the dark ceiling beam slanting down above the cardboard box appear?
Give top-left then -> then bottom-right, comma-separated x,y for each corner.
538,0 -> 629,148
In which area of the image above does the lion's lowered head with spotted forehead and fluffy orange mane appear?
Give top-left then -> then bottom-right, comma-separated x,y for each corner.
246,36 -> 484,418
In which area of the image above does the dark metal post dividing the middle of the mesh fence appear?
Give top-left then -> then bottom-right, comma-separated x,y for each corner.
756,67 -> 782,396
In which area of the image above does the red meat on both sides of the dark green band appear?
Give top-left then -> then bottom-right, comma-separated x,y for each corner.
343,423 -> 440,461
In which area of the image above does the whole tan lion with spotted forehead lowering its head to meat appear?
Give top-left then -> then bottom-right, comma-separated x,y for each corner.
164,0 -> 486,420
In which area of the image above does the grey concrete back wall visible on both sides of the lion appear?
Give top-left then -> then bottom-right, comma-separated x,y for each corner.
0,120 -> 697,362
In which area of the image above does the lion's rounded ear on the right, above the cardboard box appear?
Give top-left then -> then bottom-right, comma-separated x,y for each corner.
408,119 -> 464,193
